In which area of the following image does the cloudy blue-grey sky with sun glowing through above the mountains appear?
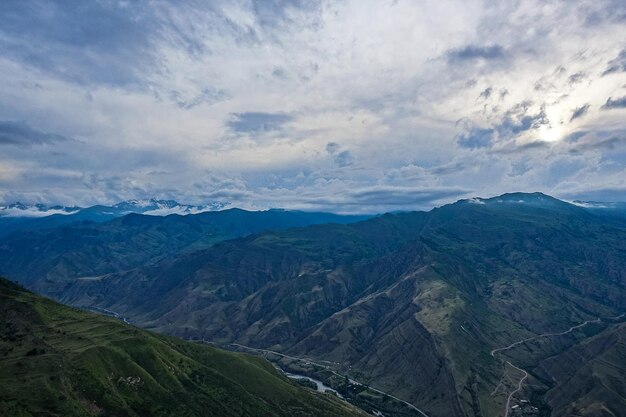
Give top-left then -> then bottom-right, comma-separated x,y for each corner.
0,0 -> 626,213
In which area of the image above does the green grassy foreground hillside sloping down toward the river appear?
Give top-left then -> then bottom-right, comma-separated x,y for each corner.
0,279 -> 363,417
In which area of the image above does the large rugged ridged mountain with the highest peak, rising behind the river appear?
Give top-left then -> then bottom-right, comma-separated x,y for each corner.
4,193 -> 626,417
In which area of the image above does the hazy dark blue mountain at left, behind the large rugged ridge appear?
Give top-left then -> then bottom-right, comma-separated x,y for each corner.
0,206 -> 365,295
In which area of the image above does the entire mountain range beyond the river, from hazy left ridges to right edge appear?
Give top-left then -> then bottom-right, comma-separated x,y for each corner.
0,193 -> 626,417
